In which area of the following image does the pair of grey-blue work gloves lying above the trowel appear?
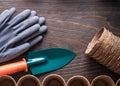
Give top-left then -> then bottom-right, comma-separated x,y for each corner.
0,7 -> 47,63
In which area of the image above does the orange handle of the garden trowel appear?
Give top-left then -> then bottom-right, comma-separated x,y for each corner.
0,58 -> 28,76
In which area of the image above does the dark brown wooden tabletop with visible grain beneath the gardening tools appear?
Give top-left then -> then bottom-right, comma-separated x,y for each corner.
0,0 -> 120,82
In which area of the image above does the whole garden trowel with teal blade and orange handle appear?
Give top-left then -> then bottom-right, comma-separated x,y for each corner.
0,48 -> 76,76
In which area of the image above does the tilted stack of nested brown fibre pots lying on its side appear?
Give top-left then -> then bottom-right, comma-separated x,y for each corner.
85,28 -> 120,74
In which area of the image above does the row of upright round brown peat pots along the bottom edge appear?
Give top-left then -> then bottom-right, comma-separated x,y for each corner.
0,74 -> 120,86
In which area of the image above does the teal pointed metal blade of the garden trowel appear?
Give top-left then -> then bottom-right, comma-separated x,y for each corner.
27,48 -> 76,75
